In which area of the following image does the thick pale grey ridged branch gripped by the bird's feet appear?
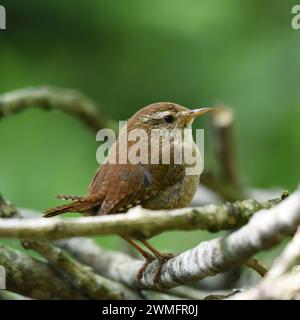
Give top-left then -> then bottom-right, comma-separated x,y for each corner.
56,190 -> 300,288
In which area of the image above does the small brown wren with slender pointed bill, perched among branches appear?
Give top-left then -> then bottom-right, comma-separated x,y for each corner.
44,102 -> 212,281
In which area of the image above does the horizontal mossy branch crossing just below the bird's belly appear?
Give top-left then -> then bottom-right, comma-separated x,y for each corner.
0,199 -> 280,240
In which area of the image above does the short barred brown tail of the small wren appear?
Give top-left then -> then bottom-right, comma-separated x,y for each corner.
43,196 -> 95,218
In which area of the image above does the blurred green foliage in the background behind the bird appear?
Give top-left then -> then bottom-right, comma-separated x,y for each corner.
0,0 -> 300,255
